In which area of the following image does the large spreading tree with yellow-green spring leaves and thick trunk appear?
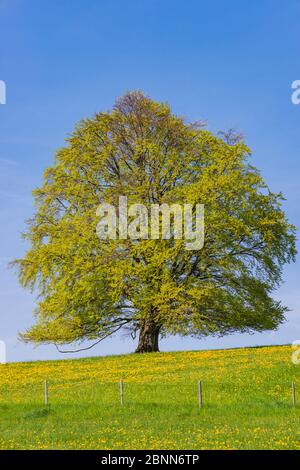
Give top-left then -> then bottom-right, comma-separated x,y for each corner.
15,92 -> 295,352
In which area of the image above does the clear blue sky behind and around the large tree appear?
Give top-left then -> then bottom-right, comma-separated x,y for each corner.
0,0 -> 300,361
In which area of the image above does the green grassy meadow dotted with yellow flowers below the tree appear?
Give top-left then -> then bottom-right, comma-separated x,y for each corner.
0,346 -> 300,450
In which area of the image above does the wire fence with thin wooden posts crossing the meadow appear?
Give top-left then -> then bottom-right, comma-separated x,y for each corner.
0,378 -> 297,408
